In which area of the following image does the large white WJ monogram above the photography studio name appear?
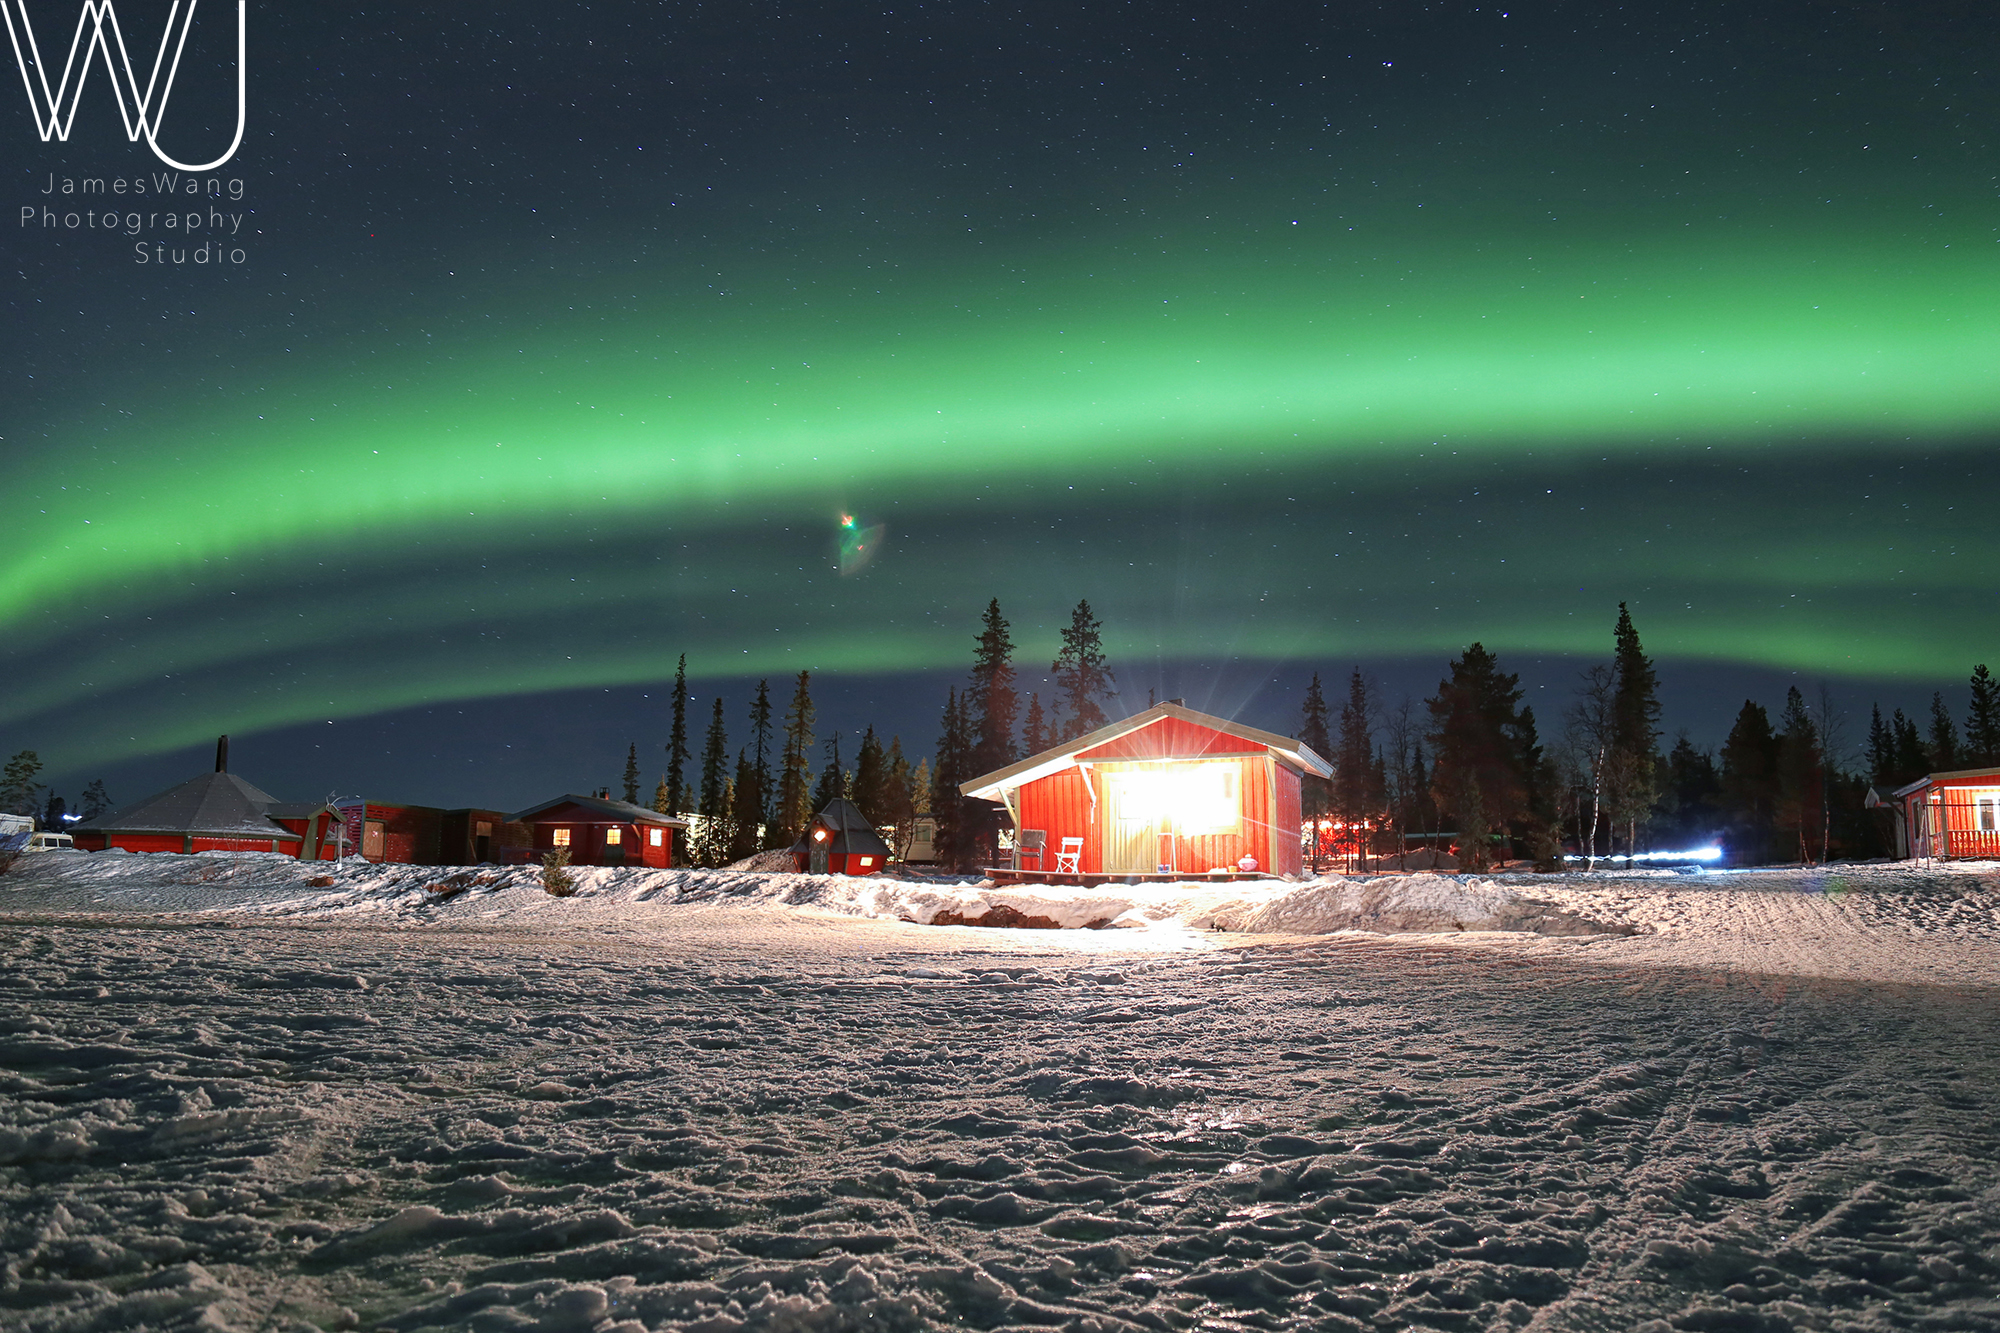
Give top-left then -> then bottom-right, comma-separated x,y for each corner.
0,0 -> 244,172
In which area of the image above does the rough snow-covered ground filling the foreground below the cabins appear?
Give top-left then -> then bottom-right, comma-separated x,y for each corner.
0,853 -> 2000,1333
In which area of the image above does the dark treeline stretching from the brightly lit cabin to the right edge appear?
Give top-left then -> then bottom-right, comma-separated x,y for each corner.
1298,602 -> 2000,869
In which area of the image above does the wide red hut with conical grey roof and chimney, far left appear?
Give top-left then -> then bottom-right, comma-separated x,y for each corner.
70,737 -> 334,857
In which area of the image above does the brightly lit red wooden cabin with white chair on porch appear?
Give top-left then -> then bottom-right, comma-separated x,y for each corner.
960,701 -> 1332,877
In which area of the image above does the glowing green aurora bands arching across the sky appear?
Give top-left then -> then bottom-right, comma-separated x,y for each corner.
0,2 -> 2000,788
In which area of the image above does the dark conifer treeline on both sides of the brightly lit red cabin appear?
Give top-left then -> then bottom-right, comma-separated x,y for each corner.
648,600 -> 2000,869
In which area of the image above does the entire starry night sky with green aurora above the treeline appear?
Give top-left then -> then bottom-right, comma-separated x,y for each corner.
0,0 -> 2000,807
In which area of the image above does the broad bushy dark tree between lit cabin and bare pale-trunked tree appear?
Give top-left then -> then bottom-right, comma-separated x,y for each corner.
1426,642 -> 1528,871
